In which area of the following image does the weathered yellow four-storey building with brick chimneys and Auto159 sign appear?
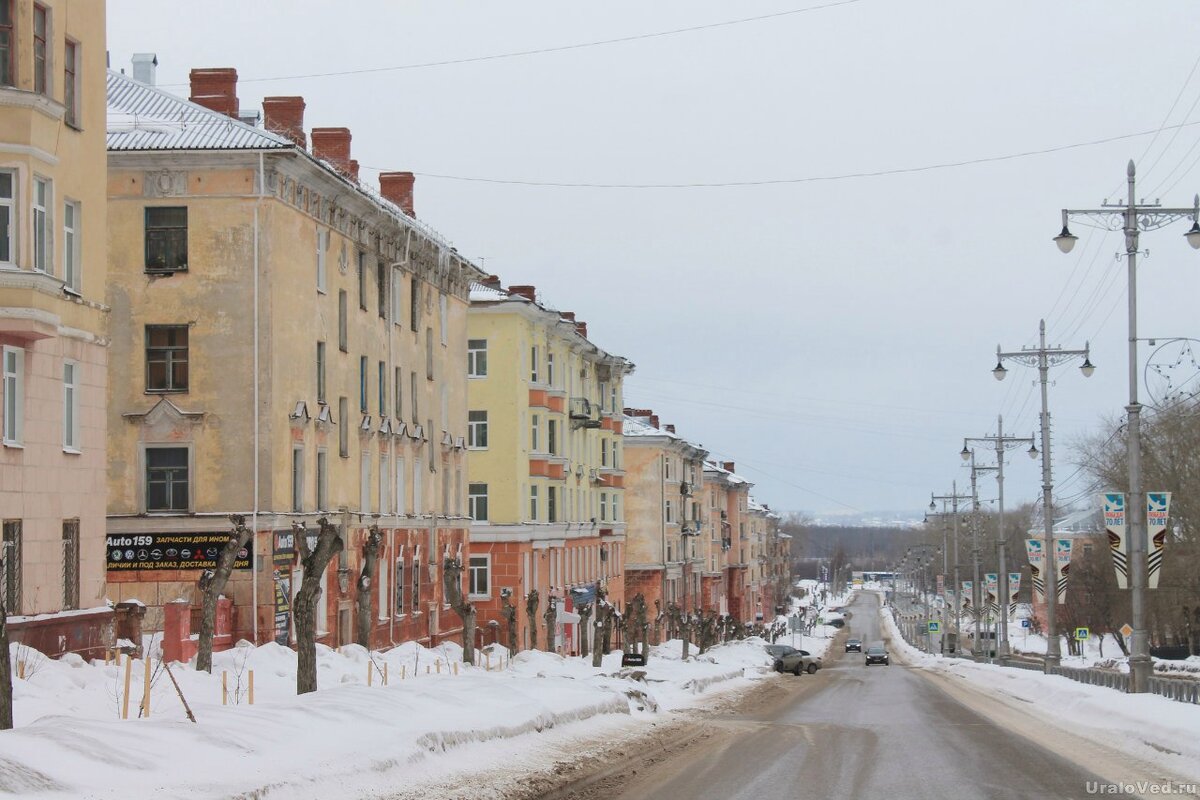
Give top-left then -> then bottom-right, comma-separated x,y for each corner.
108,61 -> 481,646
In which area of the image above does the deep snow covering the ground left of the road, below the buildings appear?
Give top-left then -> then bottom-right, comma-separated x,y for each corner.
0,627 -> 836,800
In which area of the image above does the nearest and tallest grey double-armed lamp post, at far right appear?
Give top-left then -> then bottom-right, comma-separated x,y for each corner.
1046,160 -> 1200,692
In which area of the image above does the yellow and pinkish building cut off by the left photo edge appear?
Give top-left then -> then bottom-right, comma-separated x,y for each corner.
0,0 -> 112,655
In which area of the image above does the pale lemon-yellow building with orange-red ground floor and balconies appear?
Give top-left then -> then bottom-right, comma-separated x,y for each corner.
467,276 -> 634,652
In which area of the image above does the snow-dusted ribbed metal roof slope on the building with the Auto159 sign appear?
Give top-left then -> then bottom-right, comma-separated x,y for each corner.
108,70 -> 295,151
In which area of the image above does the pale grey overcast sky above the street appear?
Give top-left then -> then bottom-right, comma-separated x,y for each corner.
108,0 -> 1200,515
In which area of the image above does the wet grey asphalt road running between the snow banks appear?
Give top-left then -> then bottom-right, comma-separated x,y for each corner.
608,593 -> 1100,800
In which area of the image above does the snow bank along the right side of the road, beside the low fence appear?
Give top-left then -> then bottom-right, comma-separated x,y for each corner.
882,599 -> 1200,781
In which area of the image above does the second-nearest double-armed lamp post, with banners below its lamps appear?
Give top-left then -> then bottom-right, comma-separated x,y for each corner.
991,319 -> 1096,670
